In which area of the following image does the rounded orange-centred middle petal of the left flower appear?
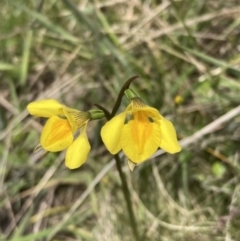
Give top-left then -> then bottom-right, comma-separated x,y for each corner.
40,116 -> 73,152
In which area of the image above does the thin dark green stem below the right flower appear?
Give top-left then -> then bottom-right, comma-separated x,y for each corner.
114,154 -> 140,241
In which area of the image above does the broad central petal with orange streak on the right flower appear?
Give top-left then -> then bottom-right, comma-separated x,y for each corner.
121,111 -> 161,163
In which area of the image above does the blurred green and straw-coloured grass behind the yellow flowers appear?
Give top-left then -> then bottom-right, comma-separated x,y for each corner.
0,0 -> 240,241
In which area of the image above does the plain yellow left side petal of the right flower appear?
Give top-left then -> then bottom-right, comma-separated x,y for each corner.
101,111 -> 126,154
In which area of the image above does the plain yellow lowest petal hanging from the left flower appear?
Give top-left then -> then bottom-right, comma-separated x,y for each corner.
65,125 -> 91,169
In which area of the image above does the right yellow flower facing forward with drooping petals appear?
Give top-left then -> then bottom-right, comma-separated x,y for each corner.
101,97 -> 181,163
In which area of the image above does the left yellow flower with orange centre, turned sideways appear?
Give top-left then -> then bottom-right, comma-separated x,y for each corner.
27,99 -> 91,169
